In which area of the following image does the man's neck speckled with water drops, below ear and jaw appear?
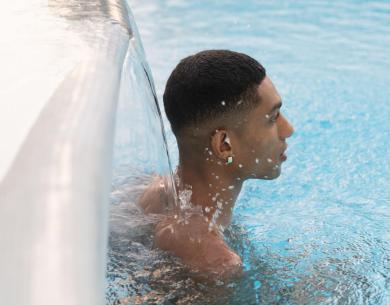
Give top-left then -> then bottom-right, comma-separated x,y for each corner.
177,158 -> 243,226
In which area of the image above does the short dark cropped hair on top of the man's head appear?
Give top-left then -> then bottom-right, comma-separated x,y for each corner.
164,50 -> 266,134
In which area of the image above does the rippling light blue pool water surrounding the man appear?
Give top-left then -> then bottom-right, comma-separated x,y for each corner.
106,0 -> 390,305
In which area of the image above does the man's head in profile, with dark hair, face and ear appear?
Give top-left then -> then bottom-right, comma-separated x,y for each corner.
164,50 -> 293,179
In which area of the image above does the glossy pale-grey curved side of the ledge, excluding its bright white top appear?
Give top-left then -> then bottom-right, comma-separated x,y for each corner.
0,1 -> 131,305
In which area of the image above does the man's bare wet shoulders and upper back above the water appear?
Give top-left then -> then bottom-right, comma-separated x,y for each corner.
138,177 -> 242,277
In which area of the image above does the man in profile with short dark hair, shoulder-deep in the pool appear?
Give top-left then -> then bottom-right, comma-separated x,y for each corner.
139,50 -> 293,276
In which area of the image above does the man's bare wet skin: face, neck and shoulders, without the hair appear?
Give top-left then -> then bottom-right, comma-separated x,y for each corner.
138,77 -> 294,277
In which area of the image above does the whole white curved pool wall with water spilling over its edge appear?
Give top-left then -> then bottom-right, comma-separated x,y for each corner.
0,0 -> 136,305
